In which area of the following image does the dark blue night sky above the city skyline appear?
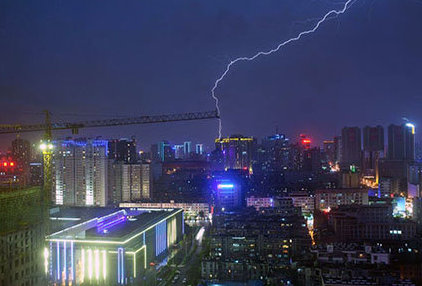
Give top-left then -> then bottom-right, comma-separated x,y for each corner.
0,0 -> 422,150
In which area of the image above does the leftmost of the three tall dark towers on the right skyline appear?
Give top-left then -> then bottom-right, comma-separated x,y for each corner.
341,127 -> 362,169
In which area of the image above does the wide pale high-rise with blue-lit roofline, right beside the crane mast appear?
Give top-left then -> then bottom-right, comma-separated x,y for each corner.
52,139 -> 108,206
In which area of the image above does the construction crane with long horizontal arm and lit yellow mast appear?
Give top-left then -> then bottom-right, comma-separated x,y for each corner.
0,110 -> 220,204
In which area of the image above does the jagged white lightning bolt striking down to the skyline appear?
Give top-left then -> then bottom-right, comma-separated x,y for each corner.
211,0 -> 356,138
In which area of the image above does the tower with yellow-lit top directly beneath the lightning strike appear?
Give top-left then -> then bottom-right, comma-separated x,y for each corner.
215,135 -> 256,170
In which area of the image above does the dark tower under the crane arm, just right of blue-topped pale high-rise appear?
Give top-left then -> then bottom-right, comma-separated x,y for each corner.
108,138 -> 138,163
